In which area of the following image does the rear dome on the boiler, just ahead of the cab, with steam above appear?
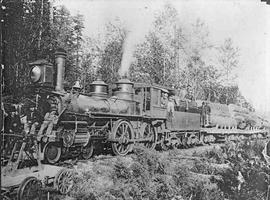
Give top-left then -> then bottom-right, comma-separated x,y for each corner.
113,79 -> 134,100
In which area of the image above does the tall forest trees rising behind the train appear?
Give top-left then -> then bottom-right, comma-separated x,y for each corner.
1,0 -> 252,109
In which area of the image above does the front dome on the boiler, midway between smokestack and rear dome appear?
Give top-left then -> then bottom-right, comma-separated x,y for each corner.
90,79 -> 108,97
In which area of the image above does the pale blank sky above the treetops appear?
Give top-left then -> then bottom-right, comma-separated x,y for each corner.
55,0 -> 270,115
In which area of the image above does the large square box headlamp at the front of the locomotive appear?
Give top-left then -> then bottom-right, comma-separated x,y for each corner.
29,59 -> 54,86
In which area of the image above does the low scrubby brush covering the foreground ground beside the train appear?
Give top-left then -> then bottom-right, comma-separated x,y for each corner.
51,141 -> 270,200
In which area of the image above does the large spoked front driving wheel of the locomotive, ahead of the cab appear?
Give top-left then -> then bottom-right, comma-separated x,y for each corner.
112,120 -> 134,156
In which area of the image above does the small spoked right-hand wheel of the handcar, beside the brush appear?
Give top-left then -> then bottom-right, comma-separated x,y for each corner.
54,169 -> 74,194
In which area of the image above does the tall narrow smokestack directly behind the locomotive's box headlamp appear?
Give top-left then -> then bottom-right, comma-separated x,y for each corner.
54,48 -> 67,91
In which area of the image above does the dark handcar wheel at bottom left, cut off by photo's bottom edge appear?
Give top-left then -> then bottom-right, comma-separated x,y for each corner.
17,176 -> 42,200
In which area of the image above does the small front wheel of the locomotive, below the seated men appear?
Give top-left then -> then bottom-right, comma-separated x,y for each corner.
45,143 -> 61,164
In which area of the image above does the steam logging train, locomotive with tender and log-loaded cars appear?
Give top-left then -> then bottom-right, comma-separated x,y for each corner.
2,49 -> 269,164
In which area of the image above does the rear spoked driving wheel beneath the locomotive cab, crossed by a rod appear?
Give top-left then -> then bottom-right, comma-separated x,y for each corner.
142,123 -> 157,150
